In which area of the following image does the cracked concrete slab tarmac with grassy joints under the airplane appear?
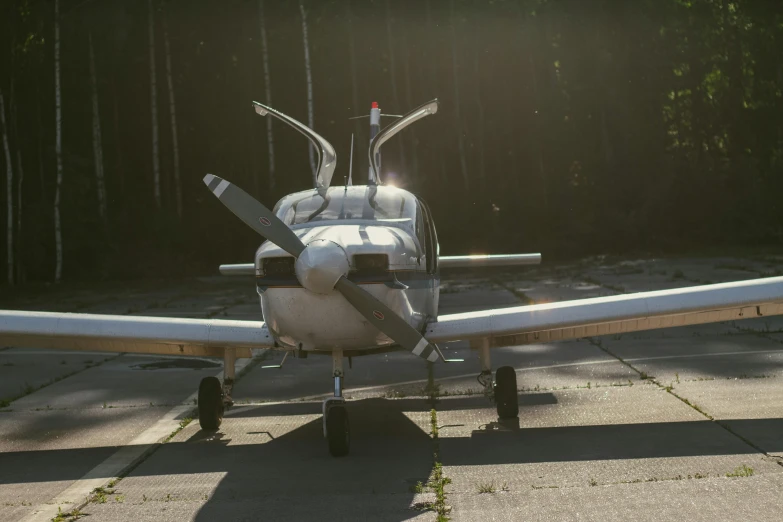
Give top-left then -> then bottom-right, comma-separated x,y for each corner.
0,254 -> 783,521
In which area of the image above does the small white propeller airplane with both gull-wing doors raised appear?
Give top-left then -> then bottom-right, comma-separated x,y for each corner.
0,100 -> 783,456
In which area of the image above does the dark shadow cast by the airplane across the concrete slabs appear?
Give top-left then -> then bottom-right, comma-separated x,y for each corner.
0,393 -> 783,520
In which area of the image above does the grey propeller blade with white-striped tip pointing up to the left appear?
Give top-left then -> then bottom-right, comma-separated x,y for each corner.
204,174 -> 305,257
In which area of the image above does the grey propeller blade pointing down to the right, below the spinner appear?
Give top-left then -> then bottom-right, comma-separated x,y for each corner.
334,276 -> 440,362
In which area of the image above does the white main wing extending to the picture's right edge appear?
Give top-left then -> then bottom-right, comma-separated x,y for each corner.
425,277 -> 783,347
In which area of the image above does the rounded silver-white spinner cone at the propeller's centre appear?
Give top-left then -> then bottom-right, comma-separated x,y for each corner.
295,239 -> 350,294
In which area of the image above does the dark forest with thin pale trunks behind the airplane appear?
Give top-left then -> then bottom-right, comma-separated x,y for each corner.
0,0 -> 783,283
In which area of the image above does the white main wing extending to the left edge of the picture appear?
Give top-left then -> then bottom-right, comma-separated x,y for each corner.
0,310 -> 274,357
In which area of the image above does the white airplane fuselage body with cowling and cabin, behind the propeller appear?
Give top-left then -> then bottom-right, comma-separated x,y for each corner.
255,186 -> 440,355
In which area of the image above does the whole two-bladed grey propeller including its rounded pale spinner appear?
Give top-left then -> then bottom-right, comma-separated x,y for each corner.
204,174 -> 443,362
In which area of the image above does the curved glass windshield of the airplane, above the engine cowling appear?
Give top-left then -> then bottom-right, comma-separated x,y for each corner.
275,186 -> 416,228
